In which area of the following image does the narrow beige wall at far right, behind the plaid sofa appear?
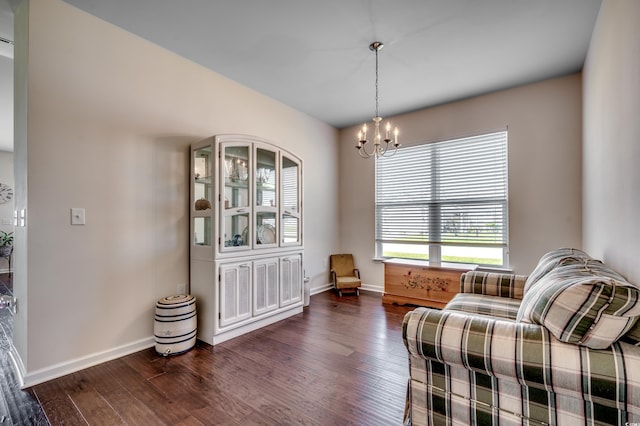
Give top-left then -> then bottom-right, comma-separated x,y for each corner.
583,0 -> 640,282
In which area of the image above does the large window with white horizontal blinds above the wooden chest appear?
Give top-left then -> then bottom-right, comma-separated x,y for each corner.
376,131 -> 508,266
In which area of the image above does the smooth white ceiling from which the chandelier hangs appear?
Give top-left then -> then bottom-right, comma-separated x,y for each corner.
0,0 -> 601,150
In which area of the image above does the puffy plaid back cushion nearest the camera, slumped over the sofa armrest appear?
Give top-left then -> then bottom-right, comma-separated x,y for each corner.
517,260 -> 640,349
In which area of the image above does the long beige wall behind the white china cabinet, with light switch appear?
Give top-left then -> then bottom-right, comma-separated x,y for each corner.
16,0 -> 338,383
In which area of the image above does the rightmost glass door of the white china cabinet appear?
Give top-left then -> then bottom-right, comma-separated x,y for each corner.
281,154 -> 302,245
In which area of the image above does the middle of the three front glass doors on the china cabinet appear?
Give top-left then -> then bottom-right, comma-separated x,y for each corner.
254,145 -> 278,248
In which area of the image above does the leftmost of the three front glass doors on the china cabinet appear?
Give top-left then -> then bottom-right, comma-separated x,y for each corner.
220,144 -> 251,250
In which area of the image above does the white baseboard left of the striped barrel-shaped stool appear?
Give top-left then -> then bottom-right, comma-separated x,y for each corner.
19,336 -> 155,389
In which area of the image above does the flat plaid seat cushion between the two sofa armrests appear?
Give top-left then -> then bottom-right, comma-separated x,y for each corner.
444,293 -> 520,320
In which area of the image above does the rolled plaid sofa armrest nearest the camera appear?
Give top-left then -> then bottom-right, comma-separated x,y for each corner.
402,308 -> 640,413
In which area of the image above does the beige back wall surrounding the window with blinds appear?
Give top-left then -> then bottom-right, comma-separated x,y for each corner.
340,74 -> 582,288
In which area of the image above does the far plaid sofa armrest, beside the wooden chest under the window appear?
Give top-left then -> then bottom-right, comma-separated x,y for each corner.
460,271 -> 527,299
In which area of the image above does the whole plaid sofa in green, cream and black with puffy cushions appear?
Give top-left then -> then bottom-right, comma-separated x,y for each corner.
403,249 -> 640,426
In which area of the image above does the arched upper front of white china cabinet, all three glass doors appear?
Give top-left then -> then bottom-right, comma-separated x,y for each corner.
215,135 -> 302,257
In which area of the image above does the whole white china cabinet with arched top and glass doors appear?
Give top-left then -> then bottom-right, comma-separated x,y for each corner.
190,135 -> 303,344
